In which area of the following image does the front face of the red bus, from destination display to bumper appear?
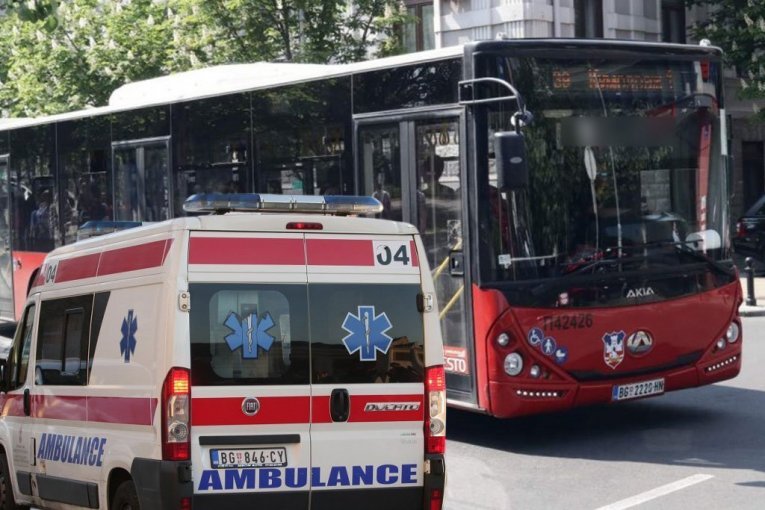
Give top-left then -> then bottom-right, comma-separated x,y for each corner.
444,41 -> 742,417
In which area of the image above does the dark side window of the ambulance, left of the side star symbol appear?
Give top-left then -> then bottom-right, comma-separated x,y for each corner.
35,294 -> 93,385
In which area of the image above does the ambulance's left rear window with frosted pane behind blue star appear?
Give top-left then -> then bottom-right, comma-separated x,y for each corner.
189,283 -> 308,386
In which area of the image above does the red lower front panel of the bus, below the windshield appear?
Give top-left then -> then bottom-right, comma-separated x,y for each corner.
473,282 -> 742,418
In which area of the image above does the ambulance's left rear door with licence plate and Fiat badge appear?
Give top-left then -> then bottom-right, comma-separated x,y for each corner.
189,232 -> 310,510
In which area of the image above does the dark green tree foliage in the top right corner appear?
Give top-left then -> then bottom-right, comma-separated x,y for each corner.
686,0 -> 765,98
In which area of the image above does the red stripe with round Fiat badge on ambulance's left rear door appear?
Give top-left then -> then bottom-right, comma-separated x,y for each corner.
191,396 -> 310,427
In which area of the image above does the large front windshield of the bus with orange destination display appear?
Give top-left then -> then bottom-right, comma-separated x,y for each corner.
479,56 -> 730,300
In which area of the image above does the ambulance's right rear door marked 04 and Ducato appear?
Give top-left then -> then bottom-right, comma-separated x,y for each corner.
306,233 -> 424,510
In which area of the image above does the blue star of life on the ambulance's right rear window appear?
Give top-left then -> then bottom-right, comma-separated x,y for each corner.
343,306 -> 393,361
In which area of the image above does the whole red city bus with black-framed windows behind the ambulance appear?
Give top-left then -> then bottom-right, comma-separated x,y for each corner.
0,39 -> 742,417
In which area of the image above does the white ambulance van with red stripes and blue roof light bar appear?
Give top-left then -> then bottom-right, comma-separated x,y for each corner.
0,195 -> 445,510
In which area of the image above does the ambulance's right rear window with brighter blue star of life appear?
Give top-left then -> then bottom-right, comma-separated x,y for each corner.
308,283 -> 425,384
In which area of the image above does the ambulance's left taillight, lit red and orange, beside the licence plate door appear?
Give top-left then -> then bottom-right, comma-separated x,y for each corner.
162,367 -> 191,460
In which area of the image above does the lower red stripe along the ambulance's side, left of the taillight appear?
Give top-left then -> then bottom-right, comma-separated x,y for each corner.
3,395 -> 158,425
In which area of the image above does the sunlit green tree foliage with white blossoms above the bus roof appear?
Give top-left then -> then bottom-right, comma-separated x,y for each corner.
0,0 -> 405,116
